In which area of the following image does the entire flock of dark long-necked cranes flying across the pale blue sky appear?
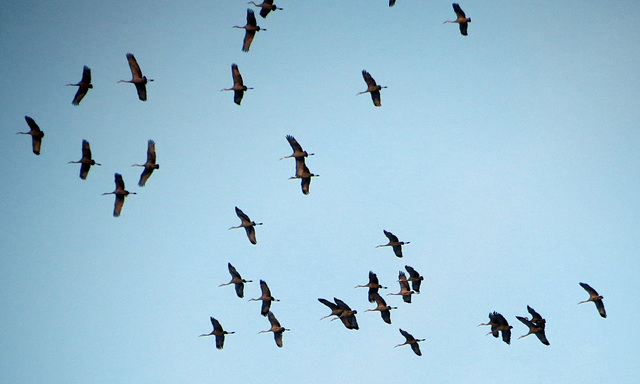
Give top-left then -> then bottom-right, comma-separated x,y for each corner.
18,0 -> 606,356
